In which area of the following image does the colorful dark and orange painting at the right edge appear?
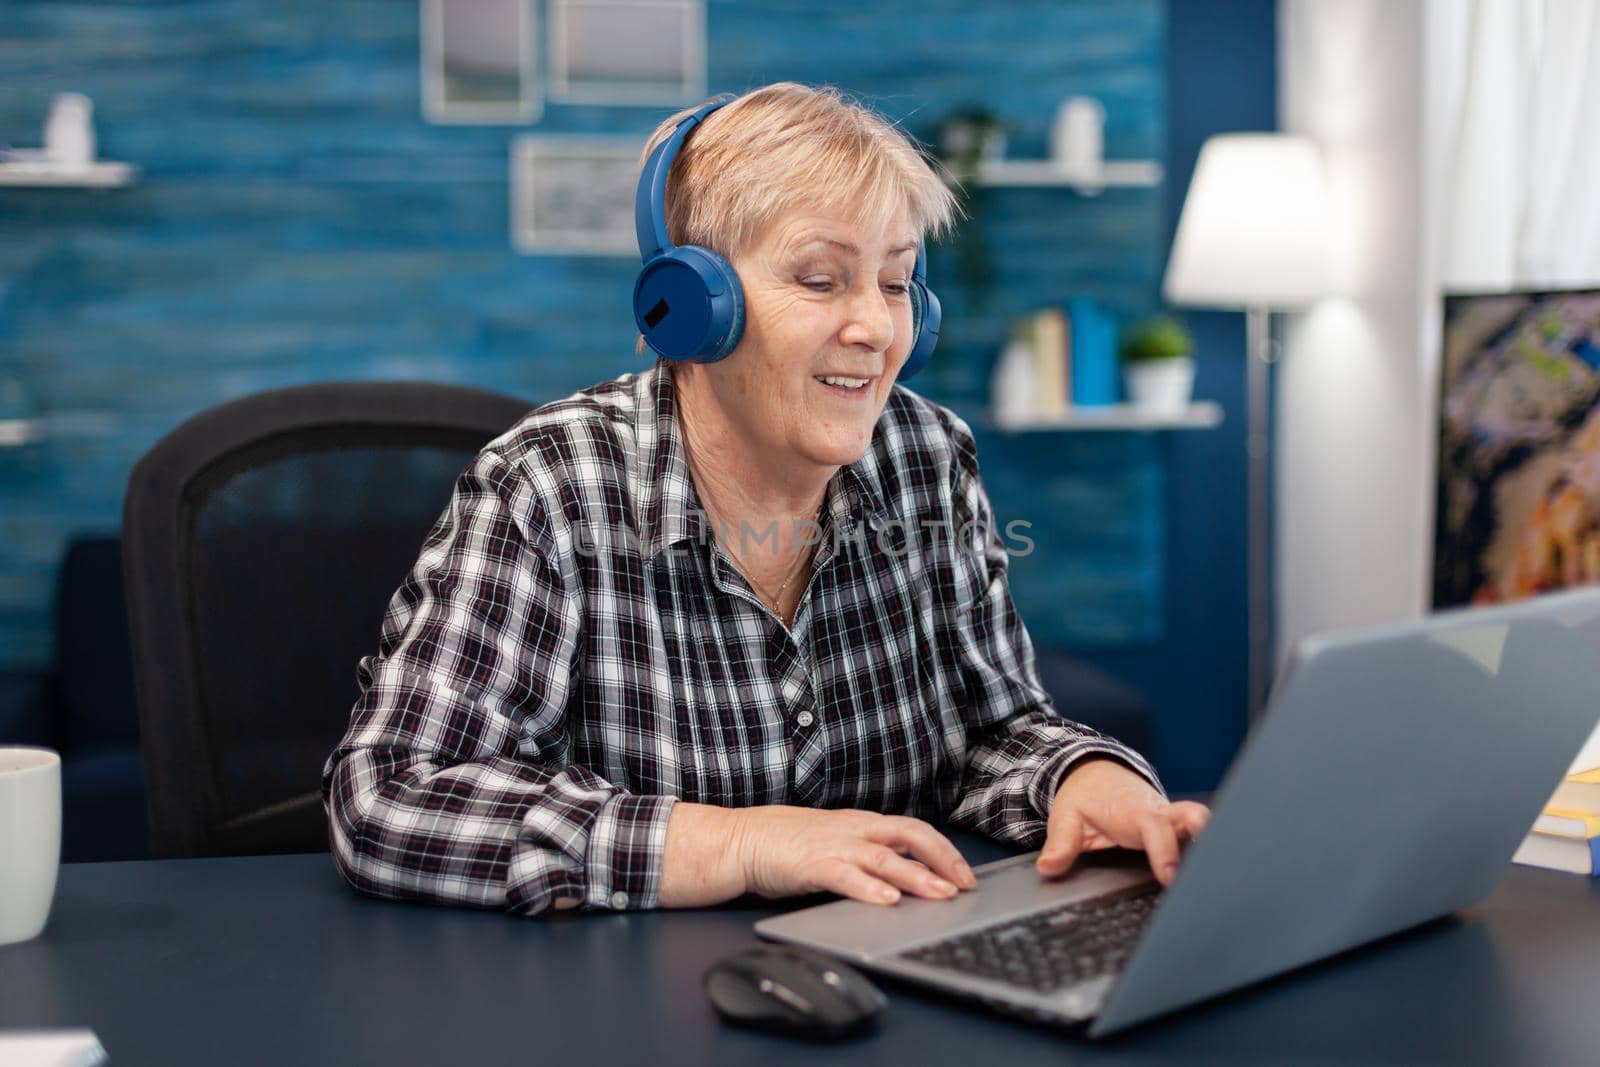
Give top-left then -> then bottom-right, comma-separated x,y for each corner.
1434,290 -> 1600,608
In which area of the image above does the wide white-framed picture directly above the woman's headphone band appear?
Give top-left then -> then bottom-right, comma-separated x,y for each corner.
549,0 -> 706,106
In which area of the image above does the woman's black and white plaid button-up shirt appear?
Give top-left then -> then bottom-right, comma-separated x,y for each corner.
322,362 -> 1160,913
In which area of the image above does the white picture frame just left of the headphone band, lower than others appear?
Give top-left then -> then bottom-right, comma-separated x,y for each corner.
510,134 -> 643,256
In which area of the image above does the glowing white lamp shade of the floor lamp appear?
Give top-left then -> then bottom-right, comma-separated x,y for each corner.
1162,133 -> 1328,307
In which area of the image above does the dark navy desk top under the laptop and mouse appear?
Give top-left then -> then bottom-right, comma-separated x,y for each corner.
0,835 -> 1600,1067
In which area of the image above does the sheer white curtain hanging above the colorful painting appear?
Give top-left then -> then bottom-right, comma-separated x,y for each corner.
1427,0 -> 1600,290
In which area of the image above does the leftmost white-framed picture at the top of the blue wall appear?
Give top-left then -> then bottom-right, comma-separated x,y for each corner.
421,0 -> 544,125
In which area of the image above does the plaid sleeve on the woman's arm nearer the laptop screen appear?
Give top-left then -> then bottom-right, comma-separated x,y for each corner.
949,426 -> 1165,848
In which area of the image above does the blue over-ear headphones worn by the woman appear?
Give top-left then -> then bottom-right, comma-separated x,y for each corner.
634,98 -> 941,381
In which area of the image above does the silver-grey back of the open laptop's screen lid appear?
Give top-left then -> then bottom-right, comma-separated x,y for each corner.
1090,589 -> 1600,1035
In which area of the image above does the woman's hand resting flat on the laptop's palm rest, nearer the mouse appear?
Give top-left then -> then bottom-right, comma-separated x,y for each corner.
734,805 -> 978,904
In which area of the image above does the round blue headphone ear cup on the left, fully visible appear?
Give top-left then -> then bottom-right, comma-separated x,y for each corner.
634,245 -> 744,363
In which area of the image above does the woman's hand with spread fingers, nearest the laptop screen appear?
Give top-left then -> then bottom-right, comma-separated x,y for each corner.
1037,758 -> 1211,886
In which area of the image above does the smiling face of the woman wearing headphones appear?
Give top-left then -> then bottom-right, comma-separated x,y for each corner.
698,208 -> 918,474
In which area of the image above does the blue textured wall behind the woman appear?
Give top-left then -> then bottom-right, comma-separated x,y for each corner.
0,0 -> 1275,789
